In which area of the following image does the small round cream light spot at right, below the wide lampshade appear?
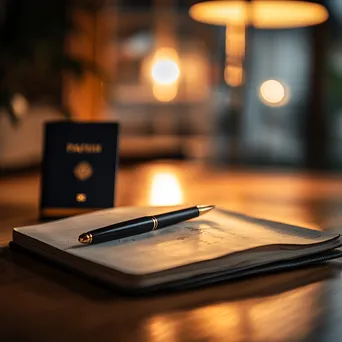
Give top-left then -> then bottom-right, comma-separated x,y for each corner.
259,80 -> 289,107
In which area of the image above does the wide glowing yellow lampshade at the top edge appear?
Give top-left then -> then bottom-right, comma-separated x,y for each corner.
190,0 -> 329,28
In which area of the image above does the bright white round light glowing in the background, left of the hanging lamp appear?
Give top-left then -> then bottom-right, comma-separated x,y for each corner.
152,59 -> 180,85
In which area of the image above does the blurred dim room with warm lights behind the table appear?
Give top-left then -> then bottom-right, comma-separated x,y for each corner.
0,0 -> 342,174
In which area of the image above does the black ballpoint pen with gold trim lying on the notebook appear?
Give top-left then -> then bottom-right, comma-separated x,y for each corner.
78,205 -> 215,245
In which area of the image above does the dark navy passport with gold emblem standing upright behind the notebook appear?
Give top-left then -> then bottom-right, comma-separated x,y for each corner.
40,121 -> 119,219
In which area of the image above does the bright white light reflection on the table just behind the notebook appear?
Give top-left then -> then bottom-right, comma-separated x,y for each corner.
150,172 -> 183,206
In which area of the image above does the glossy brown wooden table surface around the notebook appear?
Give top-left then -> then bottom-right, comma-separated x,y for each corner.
0,162 -> 342,342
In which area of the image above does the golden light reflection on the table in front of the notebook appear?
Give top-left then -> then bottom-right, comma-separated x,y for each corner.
146,280 -> 321,342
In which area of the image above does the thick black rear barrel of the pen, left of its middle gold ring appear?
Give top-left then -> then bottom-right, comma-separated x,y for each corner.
91,216 -> 154,243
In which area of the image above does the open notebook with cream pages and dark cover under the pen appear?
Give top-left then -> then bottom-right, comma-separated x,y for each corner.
12,206 -> 342,292
